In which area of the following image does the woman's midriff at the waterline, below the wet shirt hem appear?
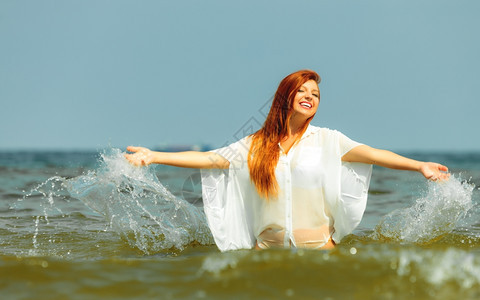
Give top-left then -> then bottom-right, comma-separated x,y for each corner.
255,228 -> 335,250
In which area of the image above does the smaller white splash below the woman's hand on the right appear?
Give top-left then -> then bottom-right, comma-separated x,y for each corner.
373,176 -> 474,244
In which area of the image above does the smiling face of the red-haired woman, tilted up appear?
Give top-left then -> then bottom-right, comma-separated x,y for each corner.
292,80 -> 320,119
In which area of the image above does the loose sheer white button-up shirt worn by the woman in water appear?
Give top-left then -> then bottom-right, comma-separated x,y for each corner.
202,125 -> 371,251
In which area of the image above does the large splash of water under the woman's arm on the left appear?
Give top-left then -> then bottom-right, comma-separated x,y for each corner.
64,149 -> 213,254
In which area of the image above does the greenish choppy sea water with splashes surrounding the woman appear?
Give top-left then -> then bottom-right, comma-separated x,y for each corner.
0,149 -> 480,299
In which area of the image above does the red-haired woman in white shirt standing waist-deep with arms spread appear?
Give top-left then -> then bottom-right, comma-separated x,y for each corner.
125,70 -> 449,251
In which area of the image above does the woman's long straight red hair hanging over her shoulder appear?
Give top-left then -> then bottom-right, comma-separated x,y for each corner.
248,70 -> 320,199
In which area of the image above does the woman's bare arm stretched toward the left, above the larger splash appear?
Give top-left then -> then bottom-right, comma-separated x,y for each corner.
125,146 -> 230,169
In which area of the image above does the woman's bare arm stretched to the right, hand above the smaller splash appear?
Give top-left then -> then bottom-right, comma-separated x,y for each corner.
342,145 -> 450,180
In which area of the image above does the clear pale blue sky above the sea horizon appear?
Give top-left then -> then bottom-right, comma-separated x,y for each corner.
0,0 -> 480,151
